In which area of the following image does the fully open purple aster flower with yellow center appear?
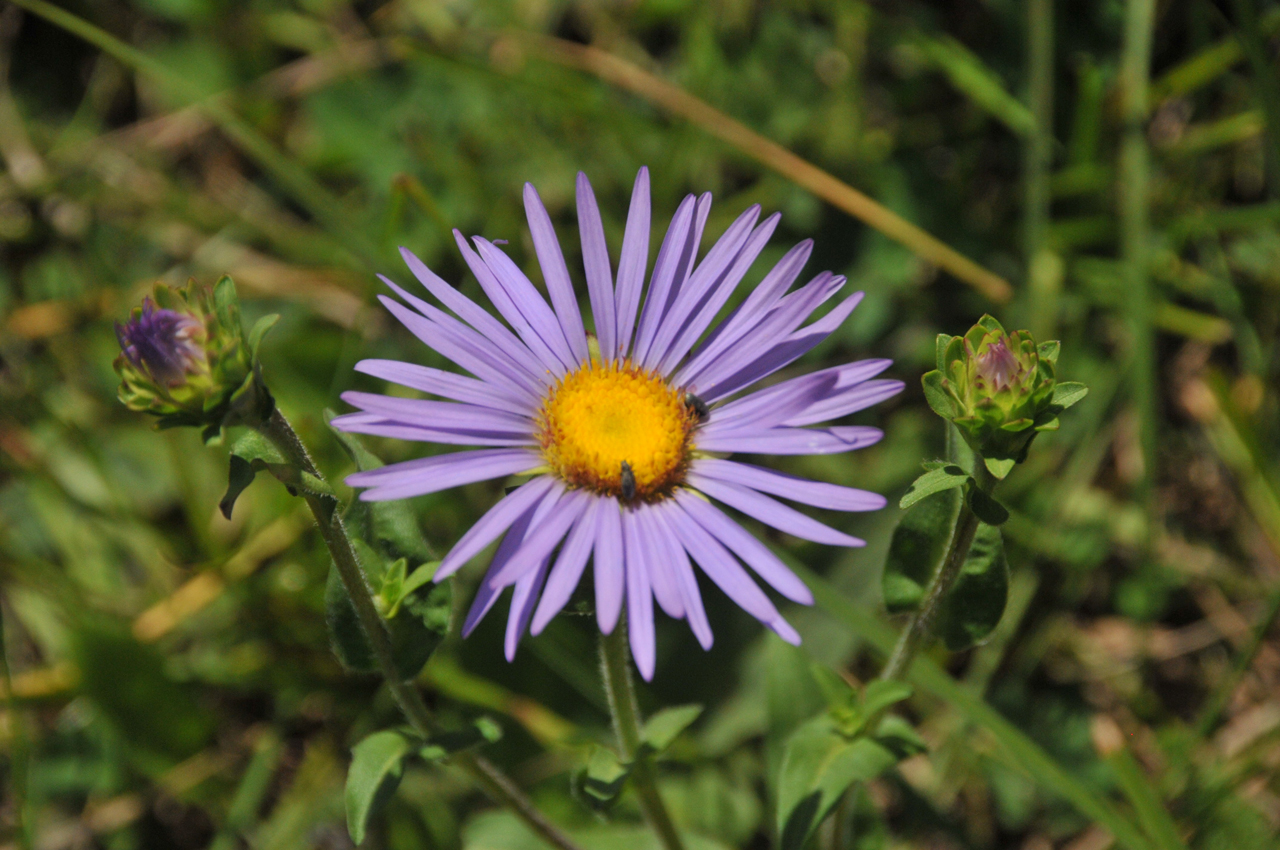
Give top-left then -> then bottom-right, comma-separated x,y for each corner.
334,169 -> 902,680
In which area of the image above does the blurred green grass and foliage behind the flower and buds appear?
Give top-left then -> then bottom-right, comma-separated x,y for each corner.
0,0 -> 1280,850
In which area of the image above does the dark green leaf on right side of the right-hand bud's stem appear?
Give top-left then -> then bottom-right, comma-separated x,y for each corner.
936,522 -> 1009,652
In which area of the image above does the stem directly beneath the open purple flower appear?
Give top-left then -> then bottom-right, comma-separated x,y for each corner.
600,617 -> 685,850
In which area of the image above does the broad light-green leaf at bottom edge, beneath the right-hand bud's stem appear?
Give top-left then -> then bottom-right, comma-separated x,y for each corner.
777,714 -> 897,850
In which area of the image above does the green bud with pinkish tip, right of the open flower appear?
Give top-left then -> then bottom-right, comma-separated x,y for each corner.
923,316 -> 1087,477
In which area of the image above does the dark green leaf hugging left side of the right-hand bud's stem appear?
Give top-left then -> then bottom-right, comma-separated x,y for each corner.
881,489 -> 960,614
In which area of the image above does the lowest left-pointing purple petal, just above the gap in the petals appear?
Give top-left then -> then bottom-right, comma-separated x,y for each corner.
347,448 -> 545,502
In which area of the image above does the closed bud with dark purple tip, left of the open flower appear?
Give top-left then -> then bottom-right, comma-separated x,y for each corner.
114,277 -> 279,440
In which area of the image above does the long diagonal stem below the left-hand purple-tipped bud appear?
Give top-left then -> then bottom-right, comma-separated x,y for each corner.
259,410 -> 580,850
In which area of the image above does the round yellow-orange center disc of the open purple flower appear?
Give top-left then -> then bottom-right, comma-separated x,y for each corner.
539,362 -> 698,502
